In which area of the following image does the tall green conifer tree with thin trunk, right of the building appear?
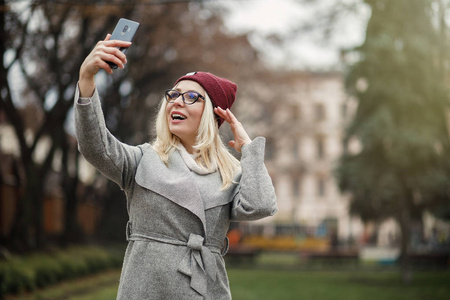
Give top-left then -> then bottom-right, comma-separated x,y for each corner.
337,0 -> 450,280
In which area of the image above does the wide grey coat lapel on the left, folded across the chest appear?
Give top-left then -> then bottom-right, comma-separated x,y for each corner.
135,148 -> 206,234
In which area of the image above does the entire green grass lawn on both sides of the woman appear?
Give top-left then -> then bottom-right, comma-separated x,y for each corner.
6,268 -> 450,300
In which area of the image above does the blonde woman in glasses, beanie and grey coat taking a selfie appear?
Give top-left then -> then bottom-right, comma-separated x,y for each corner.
75,35 -> 277,300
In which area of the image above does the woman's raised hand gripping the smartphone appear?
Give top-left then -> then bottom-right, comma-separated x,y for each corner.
79,34 -> 131,97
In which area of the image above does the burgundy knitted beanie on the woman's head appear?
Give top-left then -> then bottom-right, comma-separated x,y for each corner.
175,72 -> 237,127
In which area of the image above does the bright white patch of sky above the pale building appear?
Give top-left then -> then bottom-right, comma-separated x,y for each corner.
209,0 -> 370,70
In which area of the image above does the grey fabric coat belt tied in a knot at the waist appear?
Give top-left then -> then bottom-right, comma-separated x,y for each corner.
126,222 -> 228,297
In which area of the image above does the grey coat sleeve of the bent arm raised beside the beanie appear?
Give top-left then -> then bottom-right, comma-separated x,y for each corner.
231,137 -> 278,221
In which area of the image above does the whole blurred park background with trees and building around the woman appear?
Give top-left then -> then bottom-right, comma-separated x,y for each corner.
0,0 -> 450,299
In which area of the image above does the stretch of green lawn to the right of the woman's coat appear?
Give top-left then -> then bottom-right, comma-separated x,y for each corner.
228,269 -> 450,300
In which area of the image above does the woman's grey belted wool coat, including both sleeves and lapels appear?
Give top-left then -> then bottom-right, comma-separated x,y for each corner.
74,88 -> 277,300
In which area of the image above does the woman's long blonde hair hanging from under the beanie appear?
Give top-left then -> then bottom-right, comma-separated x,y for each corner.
152,94 -> 241,190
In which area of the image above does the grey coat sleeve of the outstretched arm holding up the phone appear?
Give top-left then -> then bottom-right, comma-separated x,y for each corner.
74,85 -> 143,189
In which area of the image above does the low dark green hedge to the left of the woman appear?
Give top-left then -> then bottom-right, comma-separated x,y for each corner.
0,246 -> 124,298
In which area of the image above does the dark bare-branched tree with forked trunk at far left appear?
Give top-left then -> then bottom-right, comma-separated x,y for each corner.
0,1 -> 135,251
